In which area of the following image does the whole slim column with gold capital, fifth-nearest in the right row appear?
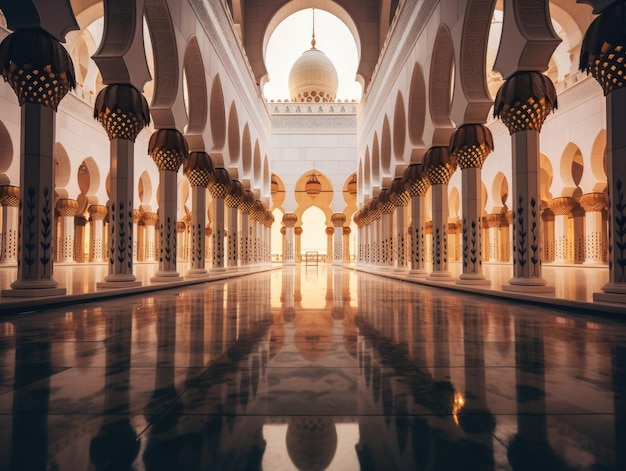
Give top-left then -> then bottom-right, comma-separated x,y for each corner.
404,164 -> 430,276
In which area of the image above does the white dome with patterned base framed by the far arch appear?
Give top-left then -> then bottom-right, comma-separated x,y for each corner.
289,46 -> 339,103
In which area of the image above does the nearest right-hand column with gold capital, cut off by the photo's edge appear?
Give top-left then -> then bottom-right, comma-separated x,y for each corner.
580,2 -> 626,304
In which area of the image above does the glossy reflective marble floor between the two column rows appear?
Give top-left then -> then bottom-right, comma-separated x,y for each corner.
0,265 -> 626,471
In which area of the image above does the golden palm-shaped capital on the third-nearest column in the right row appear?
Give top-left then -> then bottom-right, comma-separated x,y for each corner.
450,124 -> 493,169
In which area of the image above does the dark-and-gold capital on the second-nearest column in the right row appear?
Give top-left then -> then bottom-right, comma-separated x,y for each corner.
493,71 -> 557,134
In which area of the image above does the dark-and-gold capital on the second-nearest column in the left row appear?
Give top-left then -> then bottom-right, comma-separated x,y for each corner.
93,83 -> 150,142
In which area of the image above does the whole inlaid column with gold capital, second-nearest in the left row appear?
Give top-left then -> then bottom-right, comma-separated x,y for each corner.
94,84 -> 150,289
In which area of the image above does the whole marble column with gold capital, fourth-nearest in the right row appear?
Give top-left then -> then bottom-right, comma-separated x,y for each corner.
423,147 -> 456,281
